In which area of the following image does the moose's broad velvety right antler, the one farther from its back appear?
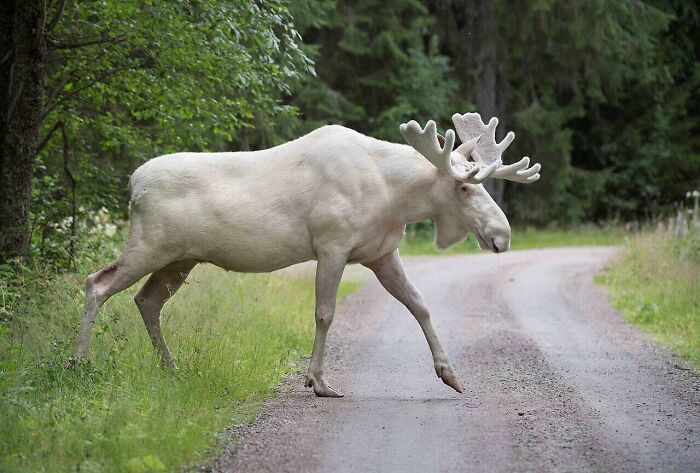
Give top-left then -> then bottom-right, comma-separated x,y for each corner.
452,113 -> 541,184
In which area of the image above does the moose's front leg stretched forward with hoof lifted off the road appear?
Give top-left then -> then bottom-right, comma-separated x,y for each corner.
365,250 -> 462,393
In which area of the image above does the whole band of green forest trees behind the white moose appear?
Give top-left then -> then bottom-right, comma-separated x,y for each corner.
0,0 -> 700,259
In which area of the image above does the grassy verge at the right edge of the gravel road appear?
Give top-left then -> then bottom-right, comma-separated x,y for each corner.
597,230 -> 700,370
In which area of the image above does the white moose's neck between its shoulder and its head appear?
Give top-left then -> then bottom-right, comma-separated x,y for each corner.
379,144 -> 447,224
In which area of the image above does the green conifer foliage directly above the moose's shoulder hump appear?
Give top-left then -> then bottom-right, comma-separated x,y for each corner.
293,0 -> 460,141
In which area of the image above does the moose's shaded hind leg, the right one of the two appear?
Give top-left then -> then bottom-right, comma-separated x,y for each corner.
134,260 -> 197,369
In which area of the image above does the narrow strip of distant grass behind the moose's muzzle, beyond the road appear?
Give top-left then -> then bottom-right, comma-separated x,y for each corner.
399,226 -> 624,255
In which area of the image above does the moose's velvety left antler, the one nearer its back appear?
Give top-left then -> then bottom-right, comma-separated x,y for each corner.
399,120 -> 501,184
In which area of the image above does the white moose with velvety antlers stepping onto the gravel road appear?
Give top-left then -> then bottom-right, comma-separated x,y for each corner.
76,113 -> 540,397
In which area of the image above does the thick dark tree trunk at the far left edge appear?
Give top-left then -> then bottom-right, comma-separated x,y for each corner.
0,0 -> 46,258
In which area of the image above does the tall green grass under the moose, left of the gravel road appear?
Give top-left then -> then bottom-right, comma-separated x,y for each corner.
0,260 -> 355,473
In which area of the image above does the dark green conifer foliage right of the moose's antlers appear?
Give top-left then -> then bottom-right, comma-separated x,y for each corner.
484,0 -> 700,224
